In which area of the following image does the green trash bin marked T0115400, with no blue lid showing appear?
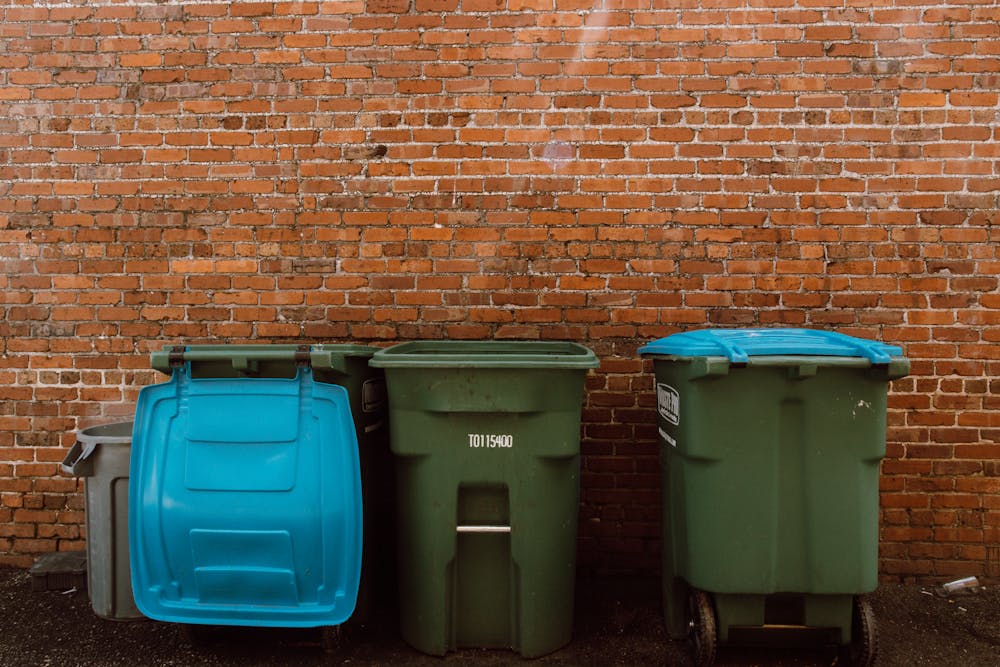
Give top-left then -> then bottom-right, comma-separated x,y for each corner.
371,341 -> 598,657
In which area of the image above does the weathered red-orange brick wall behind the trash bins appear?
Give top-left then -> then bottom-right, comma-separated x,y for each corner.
0,0 -> 1000,578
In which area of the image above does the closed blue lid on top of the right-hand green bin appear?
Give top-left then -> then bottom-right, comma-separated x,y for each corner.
639,329 -> 903,364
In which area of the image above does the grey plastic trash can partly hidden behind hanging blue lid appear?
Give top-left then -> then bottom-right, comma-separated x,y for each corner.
62,422 -> 142,620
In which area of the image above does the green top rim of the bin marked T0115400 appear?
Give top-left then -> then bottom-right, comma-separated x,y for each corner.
369,340 -> 600,368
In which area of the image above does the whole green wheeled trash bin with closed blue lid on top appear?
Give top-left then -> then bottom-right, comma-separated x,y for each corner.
639,329 -> 909,664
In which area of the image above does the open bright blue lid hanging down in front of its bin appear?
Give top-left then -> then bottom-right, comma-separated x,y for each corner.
129,367 -> 362,627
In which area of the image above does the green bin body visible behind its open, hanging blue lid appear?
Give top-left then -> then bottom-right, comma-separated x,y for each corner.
151,344 -> 394,621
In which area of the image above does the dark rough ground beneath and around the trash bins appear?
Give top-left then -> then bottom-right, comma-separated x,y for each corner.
0,568 -> 1000,667
